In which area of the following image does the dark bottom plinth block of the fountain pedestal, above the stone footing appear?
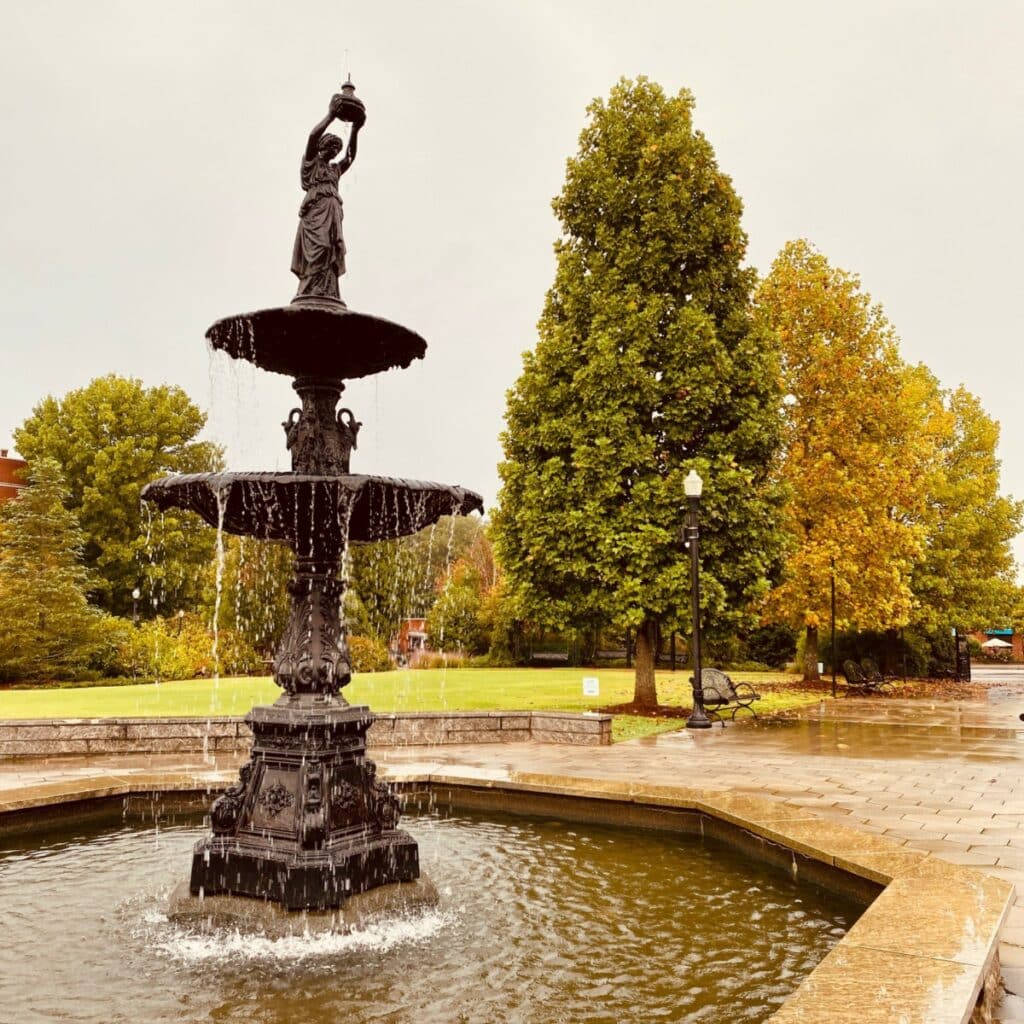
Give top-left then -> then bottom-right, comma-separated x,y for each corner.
188,828 -> 420,910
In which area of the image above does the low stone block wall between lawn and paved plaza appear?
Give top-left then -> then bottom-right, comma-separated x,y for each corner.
0,711 -> 611,759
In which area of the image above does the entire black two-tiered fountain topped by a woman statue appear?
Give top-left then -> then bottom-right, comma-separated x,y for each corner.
143,82 -> 482,910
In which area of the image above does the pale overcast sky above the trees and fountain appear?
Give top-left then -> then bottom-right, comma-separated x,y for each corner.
0,0 -> 1024,558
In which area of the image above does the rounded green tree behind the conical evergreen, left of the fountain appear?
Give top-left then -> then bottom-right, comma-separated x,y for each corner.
14,374 -> 221,614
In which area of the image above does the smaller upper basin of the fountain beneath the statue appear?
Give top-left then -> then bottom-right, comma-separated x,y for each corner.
206,297 -> 427,380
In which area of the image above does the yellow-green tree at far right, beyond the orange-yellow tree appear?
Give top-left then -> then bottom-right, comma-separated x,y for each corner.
911,376 -> 1024,632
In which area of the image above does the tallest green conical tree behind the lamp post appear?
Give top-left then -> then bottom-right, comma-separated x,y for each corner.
495,78 -> 779,706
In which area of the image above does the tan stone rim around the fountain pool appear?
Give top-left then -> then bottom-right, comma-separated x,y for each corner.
0,765 -> 1014,1024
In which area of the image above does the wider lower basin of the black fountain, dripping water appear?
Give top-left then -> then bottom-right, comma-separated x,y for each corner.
142,473 -> 483,546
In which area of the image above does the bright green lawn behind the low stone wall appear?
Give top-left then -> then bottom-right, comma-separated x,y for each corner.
0,669 -> 820,740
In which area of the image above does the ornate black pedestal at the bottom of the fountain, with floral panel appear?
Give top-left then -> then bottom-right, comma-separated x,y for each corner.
189,694 -> 420,910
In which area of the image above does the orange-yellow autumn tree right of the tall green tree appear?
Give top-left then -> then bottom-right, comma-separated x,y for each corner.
757,241 -> 941,680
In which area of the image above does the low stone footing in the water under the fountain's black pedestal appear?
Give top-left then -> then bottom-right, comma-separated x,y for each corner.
167,877 -> 438,939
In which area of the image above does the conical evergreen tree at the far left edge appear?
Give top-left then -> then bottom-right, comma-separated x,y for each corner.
0,458 -> 111,679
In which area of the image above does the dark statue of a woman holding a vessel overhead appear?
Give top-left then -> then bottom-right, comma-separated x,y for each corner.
292,83 -> 366,301
